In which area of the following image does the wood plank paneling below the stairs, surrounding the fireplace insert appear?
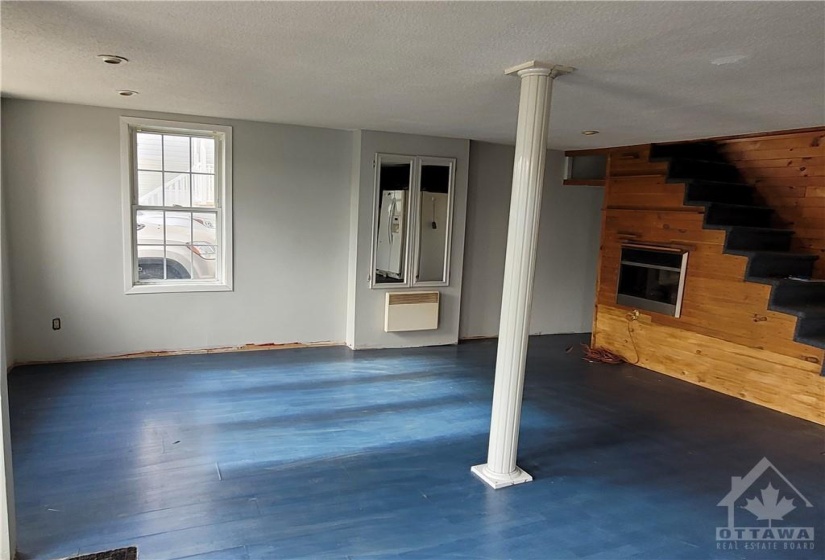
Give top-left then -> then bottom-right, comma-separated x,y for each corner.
593,133 -> 825,424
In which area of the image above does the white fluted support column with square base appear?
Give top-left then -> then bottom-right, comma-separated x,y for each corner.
470,61 -> 573,489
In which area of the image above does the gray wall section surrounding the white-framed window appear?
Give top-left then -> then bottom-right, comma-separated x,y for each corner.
2,100 -> 352,362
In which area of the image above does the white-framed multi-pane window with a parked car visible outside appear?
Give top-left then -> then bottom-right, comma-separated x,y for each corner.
120,117 -> 232,294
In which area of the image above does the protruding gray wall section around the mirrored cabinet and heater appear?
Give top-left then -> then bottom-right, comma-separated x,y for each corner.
347,130 -> 470,348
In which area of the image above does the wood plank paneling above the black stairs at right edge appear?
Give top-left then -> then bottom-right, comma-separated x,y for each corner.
721,129 -> 825,278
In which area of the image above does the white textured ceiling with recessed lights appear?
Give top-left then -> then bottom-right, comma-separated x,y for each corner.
0,0 -> 825,148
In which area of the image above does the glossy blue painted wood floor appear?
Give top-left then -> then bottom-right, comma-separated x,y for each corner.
10,335 -> 825,560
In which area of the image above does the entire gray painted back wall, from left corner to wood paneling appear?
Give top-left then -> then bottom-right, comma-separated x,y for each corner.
2,100 -> 602,362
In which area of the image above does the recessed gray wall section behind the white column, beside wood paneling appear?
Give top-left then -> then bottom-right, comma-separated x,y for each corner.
460,142 -> 603,338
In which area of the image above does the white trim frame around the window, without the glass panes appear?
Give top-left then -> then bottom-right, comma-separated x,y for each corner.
120,117 -> 233,294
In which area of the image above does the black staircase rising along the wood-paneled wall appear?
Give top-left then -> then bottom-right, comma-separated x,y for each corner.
650,142 -> 825,375
